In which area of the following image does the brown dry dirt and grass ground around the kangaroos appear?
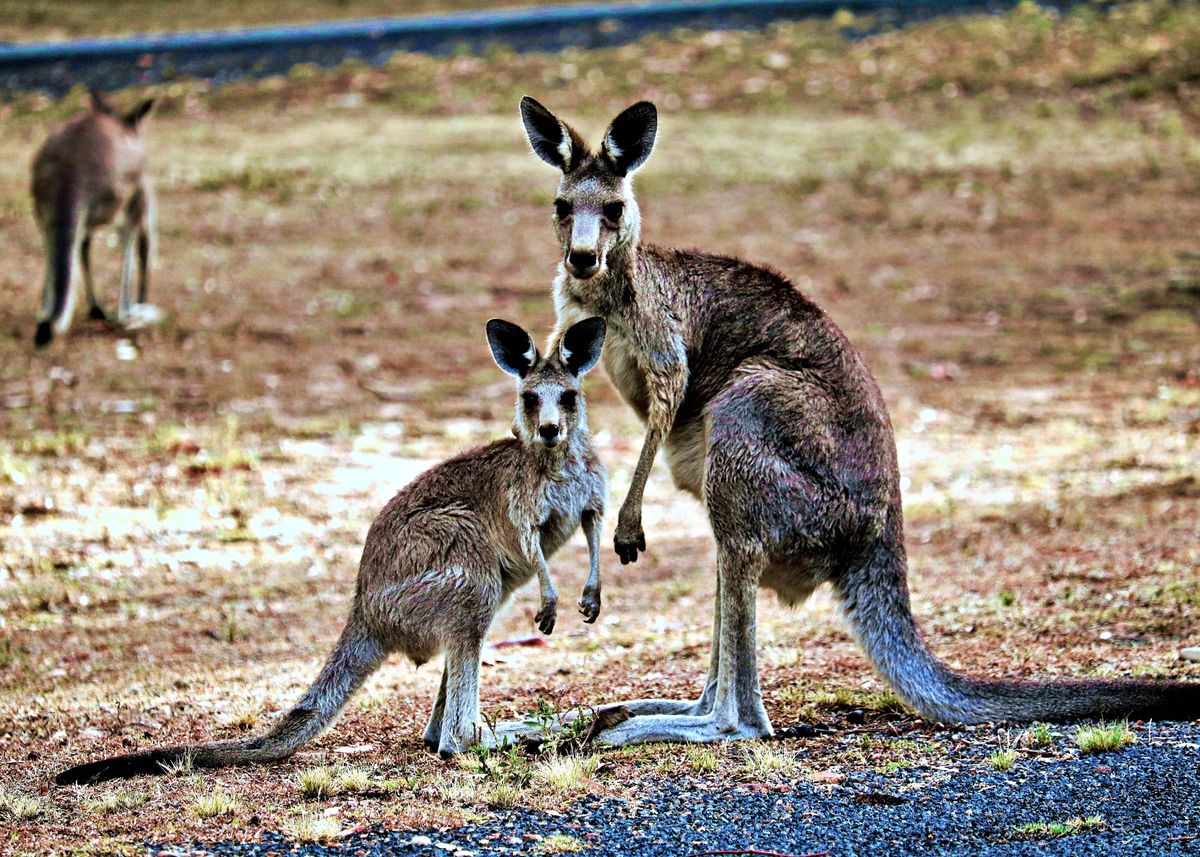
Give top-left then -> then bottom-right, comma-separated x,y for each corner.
0,4 -> 1200,853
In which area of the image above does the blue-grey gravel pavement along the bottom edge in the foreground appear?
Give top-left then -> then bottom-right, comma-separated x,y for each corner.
151,724 -> 1200,857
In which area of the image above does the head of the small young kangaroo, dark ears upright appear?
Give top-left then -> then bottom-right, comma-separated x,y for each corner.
487,318 -> 605,449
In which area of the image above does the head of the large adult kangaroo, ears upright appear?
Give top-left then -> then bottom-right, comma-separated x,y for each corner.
521,95 -> 659,280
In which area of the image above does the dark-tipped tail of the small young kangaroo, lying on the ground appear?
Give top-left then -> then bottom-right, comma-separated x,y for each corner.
54,617 -> 386,785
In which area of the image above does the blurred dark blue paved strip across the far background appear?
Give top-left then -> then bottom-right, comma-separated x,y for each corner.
0,0 -> 1058,97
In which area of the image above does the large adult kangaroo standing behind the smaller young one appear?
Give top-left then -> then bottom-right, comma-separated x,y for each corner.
521,97 -> 1200,744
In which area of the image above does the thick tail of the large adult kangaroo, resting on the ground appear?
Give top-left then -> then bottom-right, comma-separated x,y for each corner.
835,513 -> 1200,723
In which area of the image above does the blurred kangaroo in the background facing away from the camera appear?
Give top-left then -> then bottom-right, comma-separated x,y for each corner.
31,90 -> 157,347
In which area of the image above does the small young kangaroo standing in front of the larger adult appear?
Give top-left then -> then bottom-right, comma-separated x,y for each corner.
55,318 -> 607,784
